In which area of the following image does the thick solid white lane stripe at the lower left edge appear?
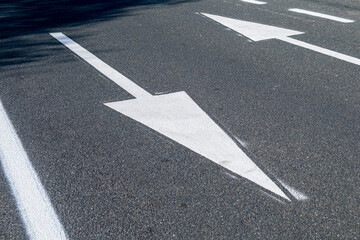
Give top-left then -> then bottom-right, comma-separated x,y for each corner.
0,101 -> 67,240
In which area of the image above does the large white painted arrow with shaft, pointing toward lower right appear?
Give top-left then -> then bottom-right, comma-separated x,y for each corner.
51,33 -> 291,201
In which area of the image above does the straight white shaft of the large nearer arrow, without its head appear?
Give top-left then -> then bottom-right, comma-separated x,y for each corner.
50,32 -> 152,98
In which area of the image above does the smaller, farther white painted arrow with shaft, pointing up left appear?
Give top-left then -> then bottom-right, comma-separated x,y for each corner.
201,13 -> 360,66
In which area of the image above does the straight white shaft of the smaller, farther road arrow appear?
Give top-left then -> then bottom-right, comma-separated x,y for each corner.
277,37 -> 360,66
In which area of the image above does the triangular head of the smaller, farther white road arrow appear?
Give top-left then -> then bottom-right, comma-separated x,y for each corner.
201,13 -> 303,42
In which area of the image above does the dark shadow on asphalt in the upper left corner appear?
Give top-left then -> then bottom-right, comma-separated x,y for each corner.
0,0 -> 194,68
